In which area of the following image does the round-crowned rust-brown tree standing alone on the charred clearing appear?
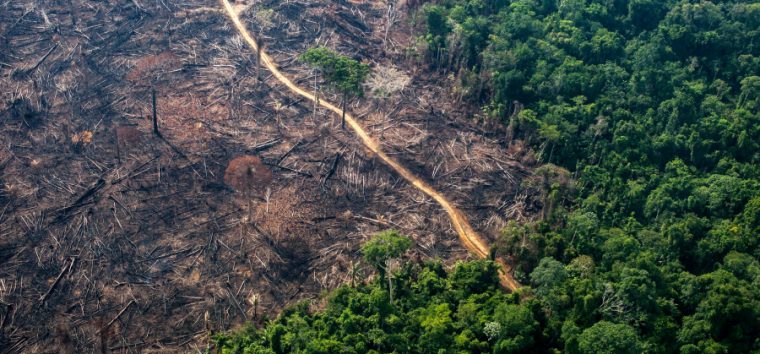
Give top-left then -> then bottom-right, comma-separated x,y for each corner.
224,156 -> 272,221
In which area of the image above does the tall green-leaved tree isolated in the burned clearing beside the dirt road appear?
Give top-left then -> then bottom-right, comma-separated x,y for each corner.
300,47 -> 369,129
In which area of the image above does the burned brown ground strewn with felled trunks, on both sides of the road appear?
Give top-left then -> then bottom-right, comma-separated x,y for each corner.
0,0 -> 535,352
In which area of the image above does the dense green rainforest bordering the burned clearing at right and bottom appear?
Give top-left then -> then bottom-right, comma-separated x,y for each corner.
217,0 -> 760,353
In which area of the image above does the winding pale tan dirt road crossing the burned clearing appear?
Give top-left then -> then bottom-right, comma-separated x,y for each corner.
220,0 -> 520,291
